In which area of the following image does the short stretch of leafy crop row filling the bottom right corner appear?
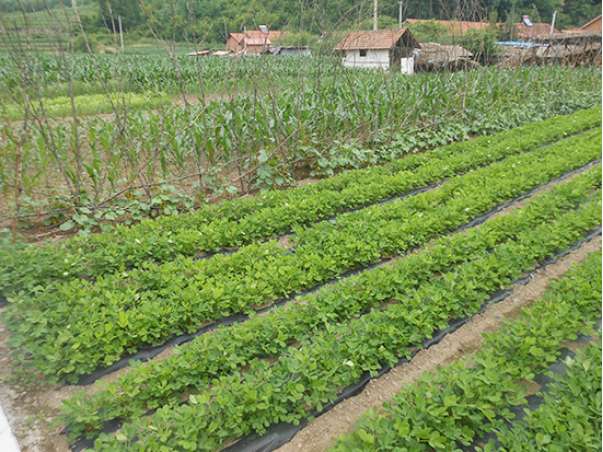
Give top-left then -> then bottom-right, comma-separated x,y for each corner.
484,337 -> 601,451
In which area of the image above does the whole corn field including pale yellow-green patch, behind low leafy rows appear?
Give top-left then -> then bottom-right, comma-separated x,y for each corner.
0,58 -> 601,240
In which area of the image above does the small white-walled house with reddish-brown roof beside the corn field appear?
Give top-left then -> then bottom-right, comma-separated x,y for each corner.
335,28 -> 420,74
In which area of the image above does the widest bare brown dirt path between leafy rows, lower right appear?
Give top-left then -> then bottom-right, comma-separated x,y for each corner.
278,237 -> 601,452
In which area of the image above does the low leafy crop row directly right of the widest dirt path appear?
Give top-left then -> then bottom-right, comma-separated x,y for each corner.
335,253 -> 601,451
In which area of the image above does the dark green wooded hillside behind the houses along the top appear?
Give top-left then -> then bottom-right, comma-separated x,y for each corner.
0,0 -> 601,43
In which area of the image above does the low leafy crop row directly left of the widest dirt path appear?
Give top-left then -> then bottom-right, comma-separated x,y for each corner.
87,194 -> 600,450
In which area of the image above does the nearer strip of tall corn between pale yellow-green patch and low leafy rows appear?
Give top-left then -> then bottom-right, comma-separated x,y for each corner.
0,62 -> 600,230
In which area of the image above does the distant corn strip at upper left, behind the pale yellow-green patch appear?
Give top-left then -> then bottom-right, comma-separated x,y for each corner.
0,52 -> 340,92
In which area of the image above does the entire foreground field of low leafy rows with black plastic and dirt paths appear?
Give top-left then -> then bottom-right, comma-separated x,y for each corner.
0,103 -> 601,451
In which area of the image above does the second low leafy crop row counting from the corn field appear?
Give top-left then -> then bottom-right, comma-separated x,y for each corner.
5,130 -> 600,378
